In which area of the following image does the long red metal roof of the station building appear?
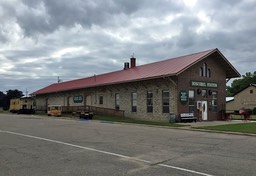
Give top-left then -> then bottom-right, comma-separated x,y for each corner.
32,49 -> 239,95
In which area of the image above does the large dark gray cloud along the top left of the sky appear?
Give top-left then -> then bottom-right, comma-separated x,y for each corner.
17,0 -> 141,36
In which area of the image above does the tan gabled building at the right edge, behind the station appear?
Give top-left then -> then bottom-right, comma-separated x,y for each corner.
226,84 -> 256,110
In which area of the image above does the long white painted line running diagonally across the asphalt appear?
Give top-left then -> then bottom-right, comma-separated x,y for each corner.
0,130 -> 213,176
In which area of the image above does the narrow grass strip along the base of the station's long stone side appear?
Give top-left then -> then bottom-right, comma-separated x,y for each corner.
93,115 -> 186,127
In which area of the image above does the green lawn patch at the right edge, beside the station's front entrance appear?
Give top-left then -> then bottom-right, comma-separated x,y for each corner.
195,122 -> 256,134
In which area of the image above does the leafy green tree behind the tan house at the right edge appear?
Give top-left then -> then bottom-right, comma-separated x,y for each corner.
227,71 -> 256,96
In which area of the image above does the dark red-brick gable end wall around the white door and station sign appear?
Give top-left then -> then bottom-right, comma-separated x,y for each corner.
178,56 -> 226,120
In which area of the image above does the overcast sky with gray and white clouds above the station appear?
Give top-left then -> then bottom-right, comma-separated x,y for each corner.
0,0 -> 256,94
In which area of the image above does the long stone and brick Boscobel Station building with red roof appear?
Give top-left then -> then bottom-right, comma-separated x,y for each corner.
32,48 -> 240,121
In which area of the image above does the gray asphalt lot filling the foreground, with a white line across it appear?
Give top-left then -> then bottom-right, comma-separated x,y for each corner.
0,114 -> 256,176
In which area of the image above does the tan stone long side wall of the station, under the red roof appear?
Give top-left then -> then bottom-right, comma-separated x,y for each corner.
36,78 -> 177,121
